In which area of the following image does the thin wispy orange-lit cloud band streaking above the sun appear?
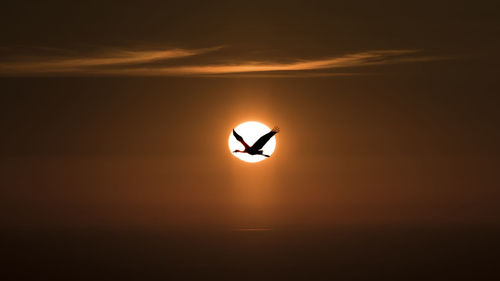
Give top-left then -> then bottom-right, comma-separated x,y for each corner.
0,47 -> 441,77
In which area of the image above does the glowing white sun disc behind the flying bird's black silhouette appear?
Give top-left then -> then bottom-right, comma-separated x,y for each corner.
228,121 -> 276,163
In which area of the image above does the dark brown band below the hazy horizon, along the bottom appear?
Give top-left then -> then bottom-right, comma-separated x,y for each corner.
0,226 -> 500,280
